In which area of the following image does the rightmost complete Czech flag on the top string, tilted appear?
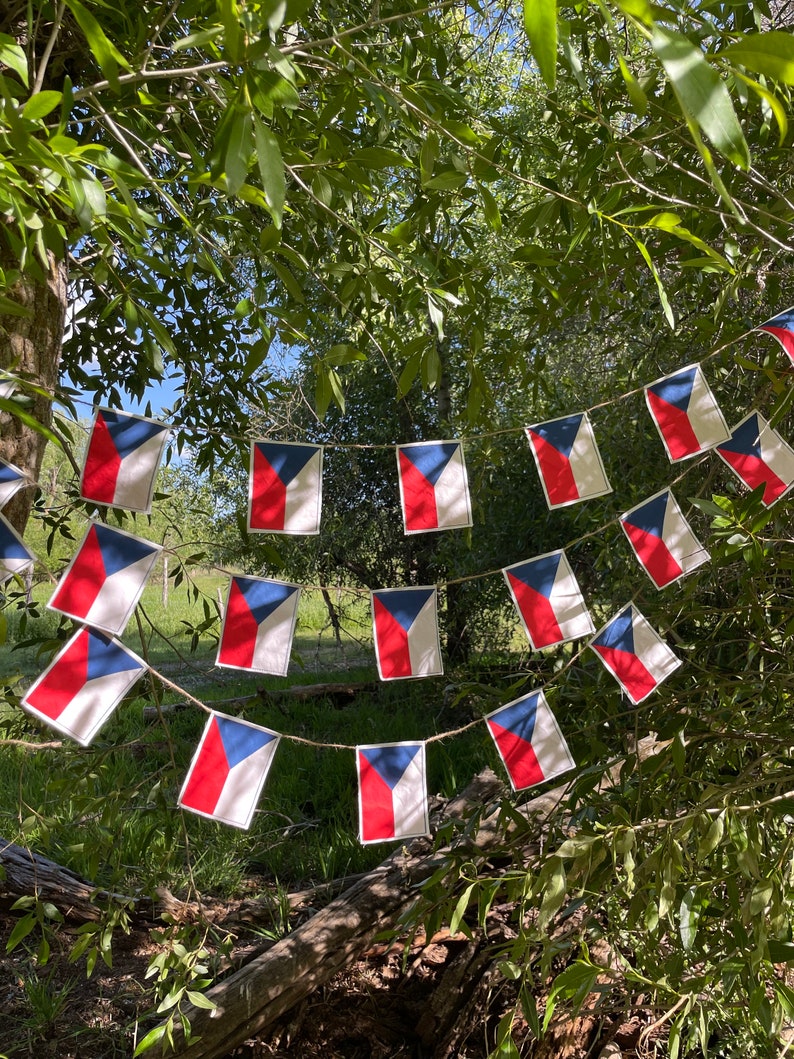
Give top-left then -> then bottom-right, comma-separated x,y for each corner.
645,364 -> 730,463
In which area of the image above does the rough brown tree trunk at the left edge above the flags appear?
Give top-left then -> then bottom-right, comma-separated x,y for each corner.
0,246 -> 67,534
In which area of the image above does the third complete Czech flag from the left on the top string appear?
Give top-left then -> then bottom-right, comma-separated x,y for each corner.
397,442 -> 472,534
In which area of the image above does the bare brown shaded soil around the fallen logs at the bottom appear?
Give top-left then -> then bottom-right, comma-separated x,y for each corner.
0,893 -> 661,1059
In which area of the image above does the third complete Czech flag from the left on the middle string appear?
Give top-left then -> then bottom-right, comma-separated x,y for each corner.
373,588 -> 444,680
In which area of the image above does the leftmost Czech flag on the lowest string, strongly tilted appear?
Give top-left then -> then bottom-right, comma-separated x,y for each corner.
21,628 -> 146,747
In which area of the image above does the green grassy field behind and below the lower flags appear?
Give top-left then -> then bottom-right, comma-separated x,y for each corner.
0,573 -> 497,895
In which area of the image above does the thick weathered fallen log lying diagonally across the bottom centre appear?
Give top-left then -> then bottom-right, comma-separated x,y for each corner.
165,738 -> 667,1059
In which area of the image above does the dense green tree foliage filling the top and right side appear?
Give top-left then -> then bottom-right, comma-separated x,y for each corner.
0,0 -> 794,1052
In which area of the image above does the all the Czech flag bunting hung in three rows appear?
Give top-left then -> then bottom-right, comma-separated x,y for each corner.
0,309 -> 794,843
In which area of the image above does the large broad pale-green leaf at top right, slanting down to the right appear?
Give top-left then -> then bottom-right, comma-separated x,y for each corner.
651,25 -> 750,169
